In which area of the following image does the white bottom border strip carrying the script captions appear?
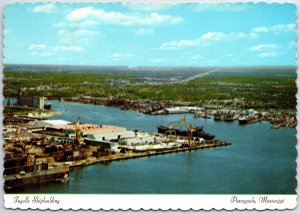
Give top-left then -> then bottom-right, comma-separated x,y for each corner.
4,194 -> 297,210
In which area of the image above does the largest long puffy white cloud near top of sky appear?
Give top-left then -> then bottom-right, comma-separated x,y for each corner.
66,7 -> 183,26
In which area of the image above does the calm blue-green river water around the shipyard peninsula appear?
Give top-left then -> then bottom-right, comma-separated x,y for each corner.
12,101 -> 297,194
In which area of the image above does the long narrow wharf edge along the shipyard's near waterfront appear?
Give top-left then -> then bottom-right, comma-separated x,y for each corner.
69,141 -> 231,167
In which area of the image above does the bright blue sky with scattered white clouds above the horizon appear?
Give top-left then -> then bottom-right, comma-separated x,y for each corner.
4,3 -> 296,66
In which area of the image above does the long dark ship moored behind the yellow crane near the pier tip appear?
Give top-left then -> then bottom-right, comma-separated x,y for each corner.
157,125 -> 215,140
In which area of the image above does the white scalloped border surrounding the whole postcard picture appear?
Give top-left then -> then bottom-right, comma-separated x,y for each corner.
0,0 -> 300,212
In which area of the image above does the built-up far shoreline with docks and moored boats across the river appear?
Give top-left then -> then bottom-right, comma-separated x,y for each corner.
63,98 -> 297,129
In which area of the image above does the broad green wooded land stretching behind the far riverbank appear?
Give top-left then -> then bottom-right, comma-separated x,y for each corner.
4,71 -> 297,111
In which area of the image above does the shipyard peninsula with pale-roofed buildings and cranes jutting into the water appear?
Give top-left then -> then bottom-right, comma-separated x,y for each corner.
3,98 -> 231,192
